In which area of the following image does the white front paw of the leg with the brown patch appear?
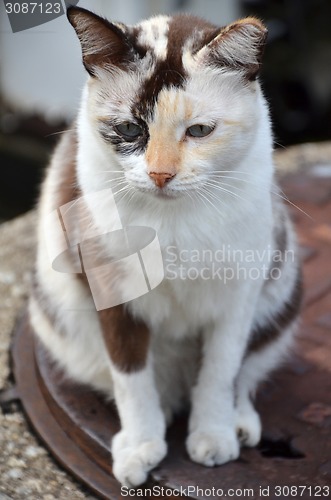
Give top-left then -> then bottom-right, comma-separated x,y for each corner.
112,431 -> 167,488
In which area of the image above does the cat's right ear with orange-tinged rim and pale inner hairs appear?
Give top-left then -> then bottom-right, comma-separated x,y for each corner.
198,17 -> 267,80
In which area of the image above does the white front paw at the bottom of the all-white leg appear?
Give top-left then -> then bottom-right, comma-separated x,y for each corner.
186,427 -> 240,467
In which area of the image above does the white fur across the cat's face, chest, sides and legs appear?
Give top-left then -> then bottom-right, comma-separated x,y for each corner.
30,12 -> 302,486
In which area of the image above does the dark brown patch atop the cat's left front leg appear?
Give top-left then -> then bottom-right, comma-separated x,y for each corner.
98,305 -> 150,373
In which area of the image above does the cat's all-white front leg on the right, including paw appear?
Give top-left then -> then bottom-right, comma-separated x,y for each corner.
186,296 -> 252,467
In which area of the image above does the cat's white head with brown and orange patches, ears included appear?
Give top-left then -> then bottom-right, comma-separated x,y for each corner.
68,7 -> 266,198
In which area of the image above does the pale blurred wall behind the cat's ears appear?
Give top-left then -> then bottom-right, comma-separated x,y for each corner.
0,0 -> 240,120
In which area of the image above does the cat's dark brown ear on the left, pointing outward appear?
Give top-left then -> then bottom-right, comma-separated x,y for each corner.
67,7 -> 134,76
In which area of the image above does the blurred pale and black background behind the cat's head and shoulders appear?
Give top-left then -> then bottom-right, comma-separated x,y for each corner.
0,0 -> 331,222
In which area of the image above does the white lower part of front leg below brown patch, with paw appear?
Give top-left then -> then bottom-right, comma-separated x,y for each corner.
112,362 -> 167,487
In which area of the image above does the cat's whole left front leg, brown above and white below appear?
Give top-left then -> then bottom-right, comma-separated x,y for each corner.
99,306 -> 167,487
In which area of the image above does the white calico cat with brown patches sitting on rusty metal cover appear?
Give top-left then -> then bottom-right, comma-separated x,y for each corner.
29,7 -> 301,487
